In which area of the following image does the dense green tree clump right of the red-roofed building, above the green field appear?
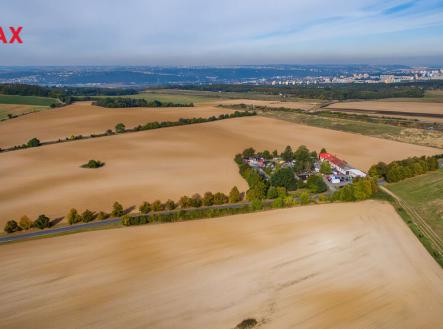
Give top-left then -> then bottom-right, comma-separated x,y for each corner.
369,156 -> 438,183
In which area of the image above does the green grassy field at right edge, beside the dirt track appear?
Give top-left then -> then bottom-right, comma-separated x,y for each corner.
386,169 -> 443,239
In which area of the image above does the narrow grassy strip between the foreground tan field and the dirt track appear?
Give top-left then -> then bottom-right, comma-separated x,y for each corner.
373,190 -> 443,268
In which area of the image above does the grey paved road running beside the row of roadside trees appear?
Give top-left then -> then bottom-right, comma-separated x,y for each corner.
0,200 -> 256,244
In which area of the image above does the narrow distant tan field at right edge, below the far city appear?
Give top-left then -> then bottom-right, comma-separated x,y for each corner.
326,101 -> 443,116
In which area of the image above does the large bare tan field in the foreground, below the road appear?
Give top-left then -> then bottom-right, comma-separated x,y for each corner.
0,201 -> 443,329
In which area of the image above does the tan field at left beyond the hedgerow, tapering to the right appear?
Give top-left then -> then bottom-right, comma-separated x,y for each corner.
0,102 -> 230,147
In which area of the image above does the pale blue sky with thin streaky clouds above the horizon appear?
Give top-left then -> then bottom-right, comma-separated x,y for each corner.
0,0 -> 443,66
